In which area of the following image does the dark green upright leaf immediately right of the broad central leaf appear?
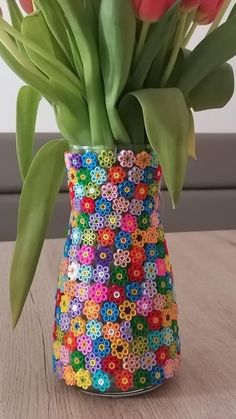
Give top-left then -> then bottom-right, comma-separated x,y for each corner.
128,1 -> 179,90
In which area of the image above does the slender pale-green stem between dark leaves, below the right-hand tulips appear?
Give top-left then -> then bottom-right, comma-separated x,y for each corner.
160,13 -> 187,87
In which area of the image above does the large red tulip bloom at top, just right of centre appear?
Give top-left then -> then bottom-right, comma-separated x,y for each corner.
133,0 -> 175,22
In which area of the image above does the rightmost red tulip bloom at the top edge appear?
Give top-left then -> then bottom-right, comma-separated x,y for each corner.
194,0 -> 224,25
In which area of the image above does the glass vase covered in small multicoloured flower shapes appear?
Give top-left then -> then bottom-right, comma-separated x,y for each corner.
53,147 -> 180,396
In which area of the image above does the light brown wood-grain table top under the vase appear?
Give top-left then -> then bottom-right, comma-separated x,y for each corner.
0,231 -> 236,419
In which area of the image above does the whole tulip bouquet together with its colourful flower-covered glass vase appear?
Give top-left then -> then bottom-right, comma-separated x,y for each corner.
0,0 -> 236,395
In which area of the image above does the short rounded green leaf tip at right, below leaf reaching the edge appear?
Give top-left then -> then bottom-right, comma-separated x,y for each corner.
188,63 -> 234,112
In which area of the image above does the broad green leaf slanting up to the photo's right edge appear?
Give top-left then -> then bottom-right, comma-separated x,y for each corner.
177,15 -> 236,97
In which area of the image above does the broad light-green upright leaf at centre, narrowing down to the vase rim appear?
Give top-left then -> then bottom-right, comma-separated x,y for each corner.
99,0 -> 136,143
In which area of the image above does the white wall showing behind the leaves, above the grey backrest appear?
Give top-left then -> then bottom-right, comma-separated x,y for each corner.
0,0 -> 236,132
